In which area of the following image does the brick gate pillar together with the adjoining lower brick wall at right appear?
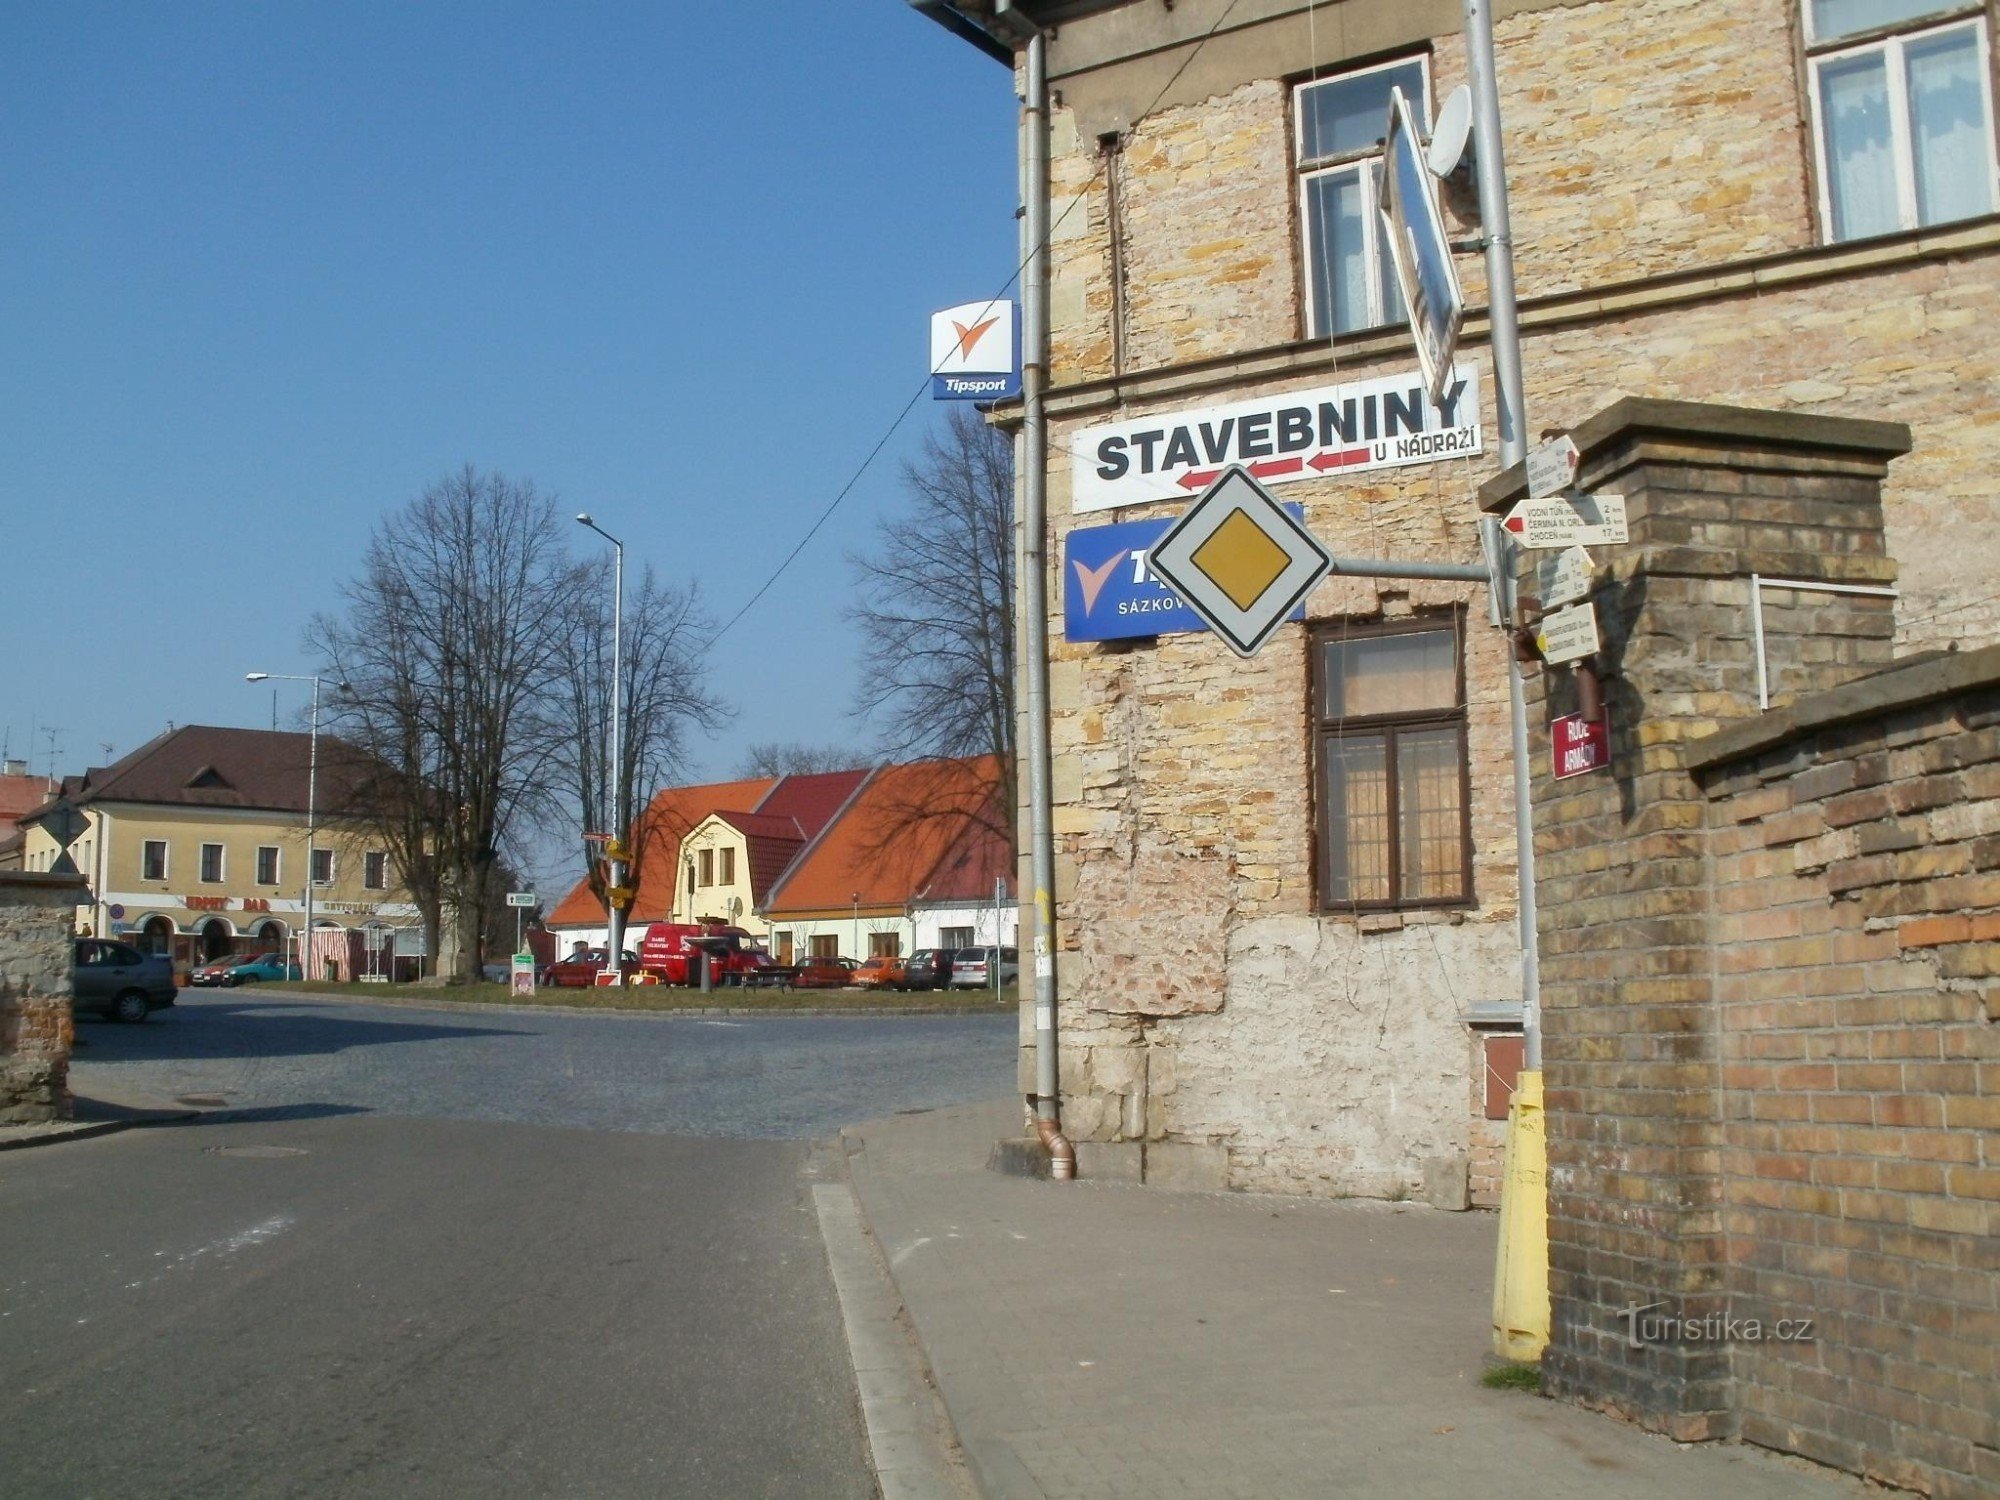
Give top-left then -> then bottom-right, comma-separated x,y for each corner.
1484,402 -> 2000,1494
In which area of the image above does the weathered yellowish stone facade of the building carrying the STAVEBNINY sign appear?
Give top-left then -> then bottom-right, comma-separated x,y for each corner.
928,0 -> 2000,1194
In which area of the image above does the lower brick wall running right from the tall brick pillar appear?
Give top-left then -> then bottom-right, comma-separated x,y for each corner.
1696,646 -> 2000,1496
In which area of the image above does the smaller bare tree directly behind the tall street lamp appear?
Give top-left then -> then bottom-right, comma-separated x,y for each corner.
544,560 -> 730,928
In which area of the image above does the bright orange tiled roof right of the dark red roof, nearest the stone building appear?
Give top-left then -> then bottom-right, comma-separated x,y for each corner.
764,756 -> 1006,914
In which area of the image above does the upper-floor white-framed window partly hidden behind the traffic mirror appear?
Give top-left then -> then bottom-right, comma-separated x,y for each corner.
1292,58 -> 1430,338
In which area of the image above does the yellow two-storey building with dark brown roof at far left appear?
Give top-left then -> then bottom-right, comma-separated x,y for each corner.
22,724 -> 422,976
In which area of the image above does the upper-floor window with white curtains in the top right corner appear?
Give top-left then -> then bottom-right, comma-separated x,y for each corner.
1806,0 -> 2000,240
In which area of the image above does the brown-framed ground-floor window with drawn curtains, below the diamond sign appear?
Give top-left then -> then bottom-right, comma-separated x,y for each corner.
1312,614 -> 1472,912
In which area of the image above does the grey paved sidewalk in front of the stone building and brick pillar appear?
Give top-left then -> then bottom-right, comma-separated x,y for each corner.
844,1100 -> 1880,1500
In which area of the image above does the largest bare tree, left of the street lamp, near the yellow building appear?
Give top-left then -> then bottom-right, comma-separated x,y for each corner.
306,464 -> 582,976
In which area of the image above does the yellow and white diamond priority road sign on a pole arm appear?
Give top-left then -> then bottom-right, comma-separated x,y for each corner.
1150,466 -> 1334,656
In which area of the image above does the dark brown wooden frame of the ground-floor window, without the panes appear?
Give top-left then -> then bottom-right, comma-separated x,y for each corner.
1306,608 -> 1478,914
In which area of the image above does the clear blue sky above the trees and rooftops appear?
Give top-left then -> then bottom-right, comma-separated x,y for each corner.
0,0 -> 1016,812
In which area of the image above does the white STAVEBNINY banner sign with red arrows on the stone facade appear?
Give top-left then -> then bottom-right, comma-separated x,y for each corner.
1070,364 -> 1482,512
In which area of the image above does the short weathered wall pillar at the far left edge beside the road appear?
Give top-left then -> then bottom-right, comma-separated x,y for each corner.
0,870 -> 84,1124
